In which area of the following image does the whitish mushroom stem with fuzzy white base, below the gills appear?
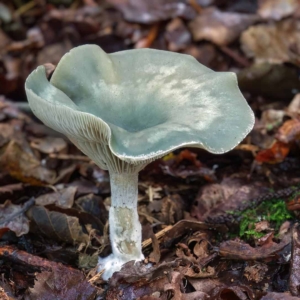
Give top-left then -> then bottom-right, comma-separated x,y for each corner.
98,172 -> 144,280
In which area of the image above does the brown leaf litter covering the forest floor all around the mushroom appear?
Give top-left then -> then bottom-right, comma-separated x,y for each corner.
0,0 -> 300,300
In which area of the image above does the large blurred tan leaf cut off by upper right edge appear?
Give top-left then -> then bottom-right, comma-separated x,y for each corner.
241,19 -> 300,66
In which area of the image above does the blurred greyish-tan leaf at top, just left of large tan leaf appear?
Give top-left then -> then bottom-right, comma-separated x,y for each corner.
189,7 -> 259,46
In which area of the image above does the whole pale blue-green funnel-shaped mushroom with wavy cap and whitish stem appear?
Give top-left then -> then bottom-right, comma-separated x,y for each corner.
25,45 -> 254,280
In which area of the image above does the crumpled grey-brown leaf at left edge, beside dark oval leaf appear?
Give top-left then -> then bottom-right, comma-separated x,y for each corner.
0,200 -> 33,236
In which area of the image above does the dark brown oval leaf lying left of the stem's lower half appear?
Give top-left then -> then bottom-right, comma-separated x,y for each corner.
27,206 -> 89,243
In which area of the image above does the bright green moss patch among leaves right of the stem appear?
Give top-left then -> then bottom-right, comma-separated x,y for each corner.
239,199 -> 293,239
